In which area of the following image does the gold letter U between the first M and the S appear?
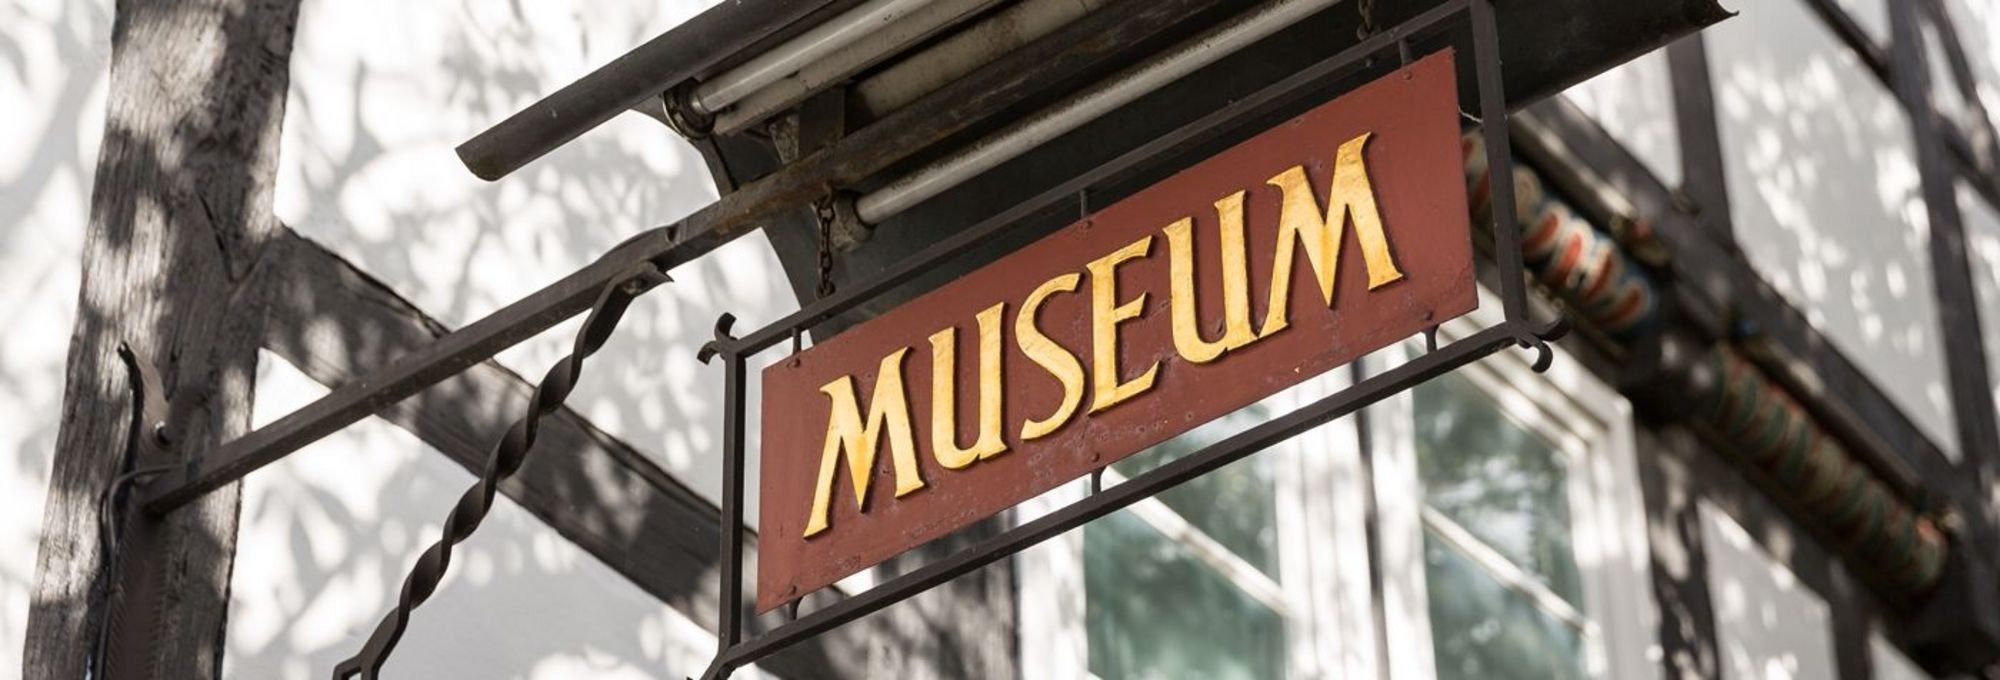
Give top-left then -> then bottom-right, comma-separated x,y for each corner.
930,302 -> 1006,470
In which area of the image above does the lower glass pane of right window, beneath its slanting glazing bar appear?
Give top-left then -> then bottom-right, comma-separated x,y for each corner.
1424,530 -> 1584,680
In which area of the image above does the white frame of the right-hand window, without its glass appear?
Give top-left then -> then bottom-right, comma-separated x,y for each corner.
1360,286 -> 1662,680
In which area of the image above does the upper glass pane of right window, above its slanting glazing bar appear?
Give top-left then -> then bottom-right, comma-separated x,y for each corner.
1414,374 -> 1582,604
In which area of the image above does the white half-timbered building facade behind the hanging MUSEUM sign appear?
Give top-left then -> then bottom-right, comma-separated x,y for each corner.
11,0 -> 2000,680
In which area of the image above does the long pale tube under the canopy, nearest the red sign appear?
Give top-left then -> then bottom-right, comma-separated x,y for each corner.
854,0 -> 1340,224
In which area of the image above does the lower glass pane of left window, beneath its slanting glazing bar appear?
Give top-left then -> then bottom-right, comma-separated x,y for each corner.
1084,512 -> 1284,680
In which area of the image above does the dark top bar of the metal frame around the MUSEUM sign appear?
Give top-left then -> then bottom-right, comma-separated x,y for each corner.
730,0 -> 1468,354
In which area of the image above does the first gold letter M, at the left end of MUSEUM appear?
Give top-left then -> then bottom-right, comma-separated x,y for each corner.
806,348 -> 924,538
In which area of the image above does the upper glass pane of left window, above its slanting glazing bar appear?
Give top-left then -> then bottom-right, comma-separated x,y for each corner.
1112,404 -> 1278,580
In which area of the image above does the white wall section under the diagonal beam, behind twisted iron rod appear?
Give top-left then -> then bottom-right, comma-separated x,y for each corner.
222,354 -> 760,680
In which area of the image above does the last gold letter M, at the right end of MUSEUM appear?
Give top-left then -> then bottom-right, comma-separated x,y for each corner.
1258,132 -> 1402,336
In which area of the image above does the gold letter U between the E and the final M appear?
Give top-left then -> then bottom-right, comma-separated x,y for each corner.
1166,192 -> 1258,364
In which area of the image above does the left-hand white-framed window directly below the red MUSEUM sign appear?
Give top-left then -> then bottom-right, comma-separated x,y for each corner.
1016,372 -> 1374,680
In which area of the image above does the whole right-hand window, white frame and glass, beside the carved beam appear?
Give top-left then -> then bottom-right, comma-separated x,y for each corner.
1368,290 -> 1658,680
